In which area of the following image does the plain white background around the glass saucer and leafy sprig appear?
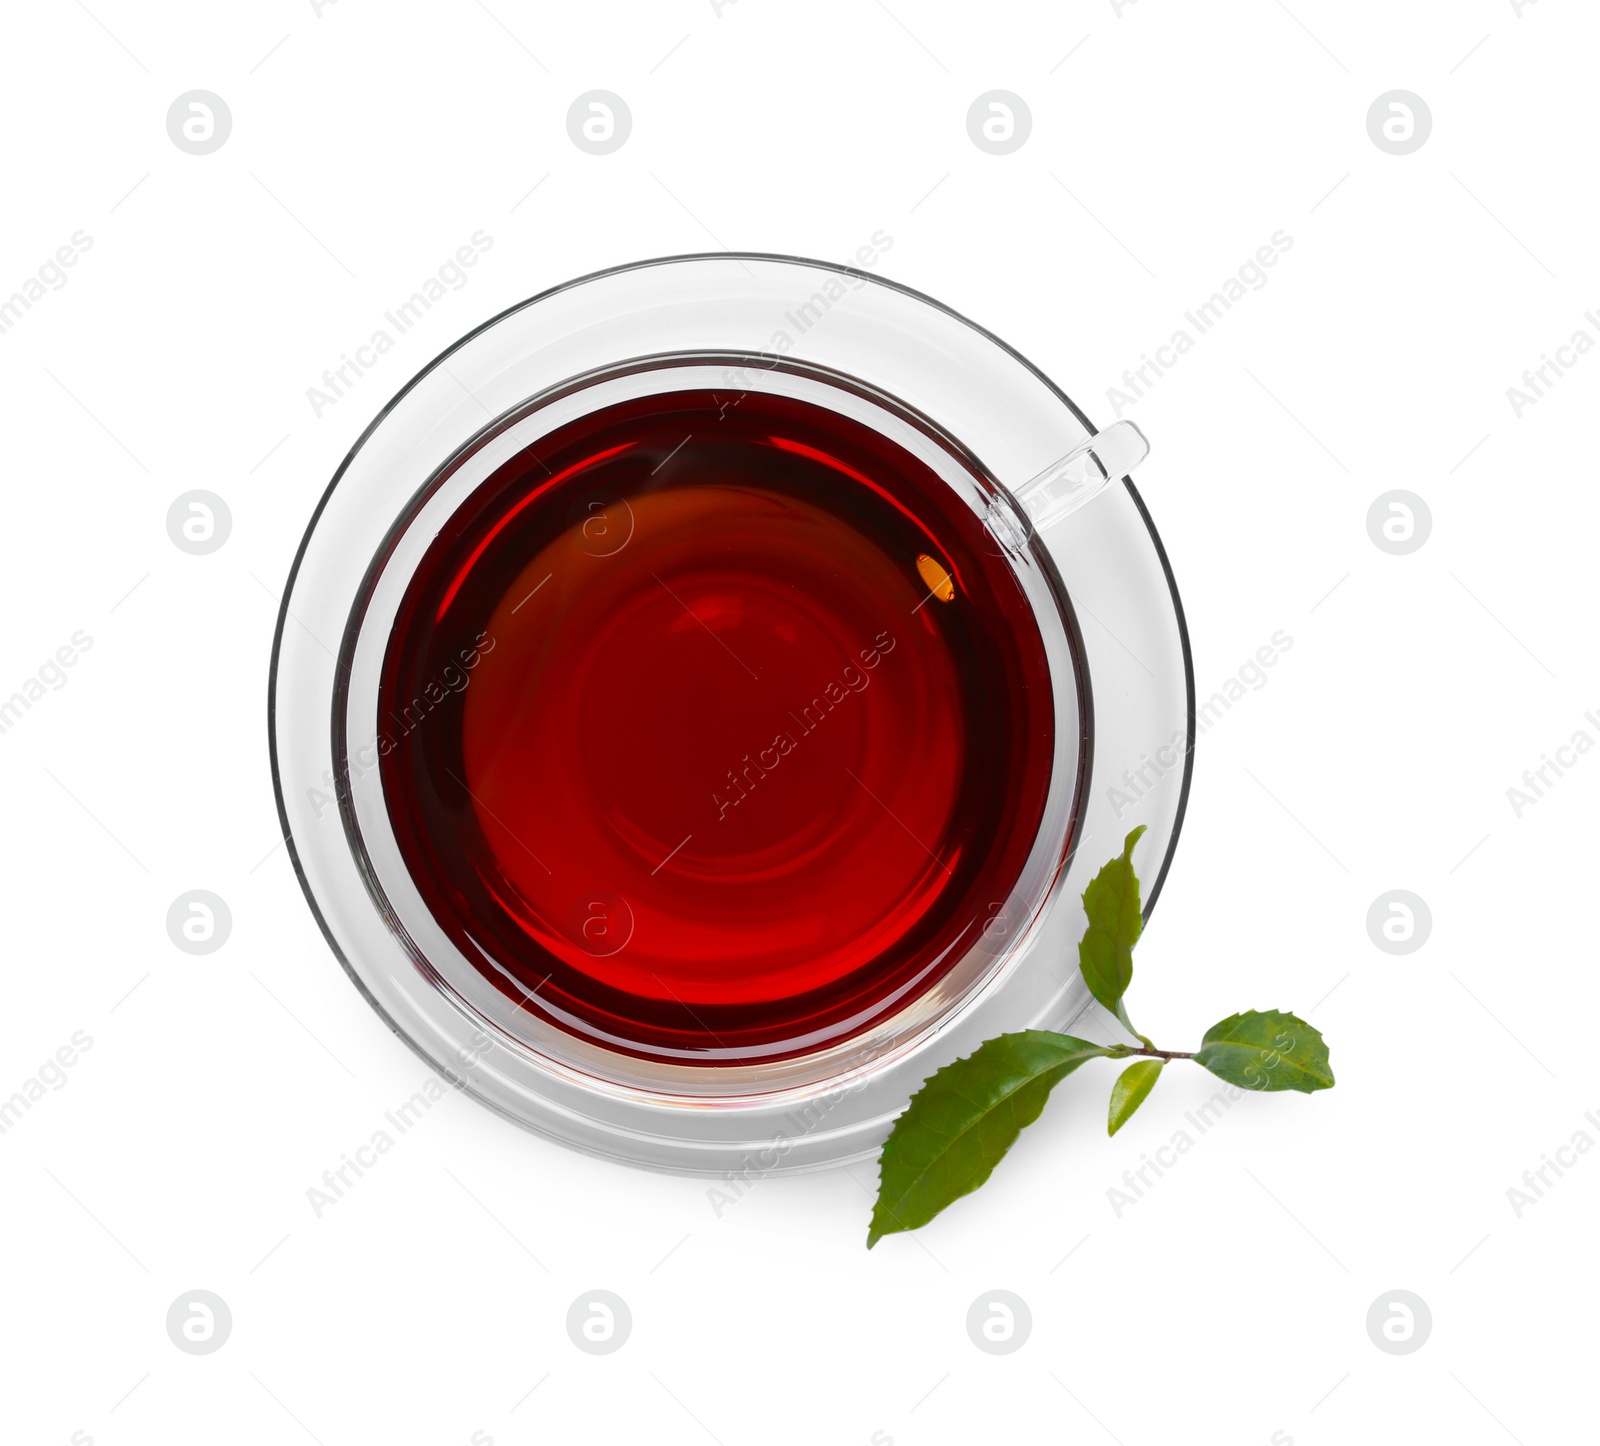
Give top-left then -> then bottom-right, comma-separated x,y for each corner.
0,0 -> 1600,1446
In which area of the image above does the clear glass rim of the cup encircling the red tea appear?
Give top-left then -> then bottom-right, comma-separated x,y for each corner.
331,352 -> 1093,1104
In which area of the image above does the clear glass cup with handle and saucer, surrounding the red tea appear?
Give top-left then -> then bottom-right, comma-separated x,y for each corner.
269,254 -> 1194,1177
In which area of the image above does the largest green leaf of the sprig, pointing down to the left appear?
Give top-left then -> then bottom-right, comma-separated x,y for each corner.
867,1029 -> 1112,1249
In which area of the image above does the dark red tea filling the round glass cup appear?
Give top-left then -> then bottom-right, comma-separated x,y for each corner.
379,383 -> 1054,1065
